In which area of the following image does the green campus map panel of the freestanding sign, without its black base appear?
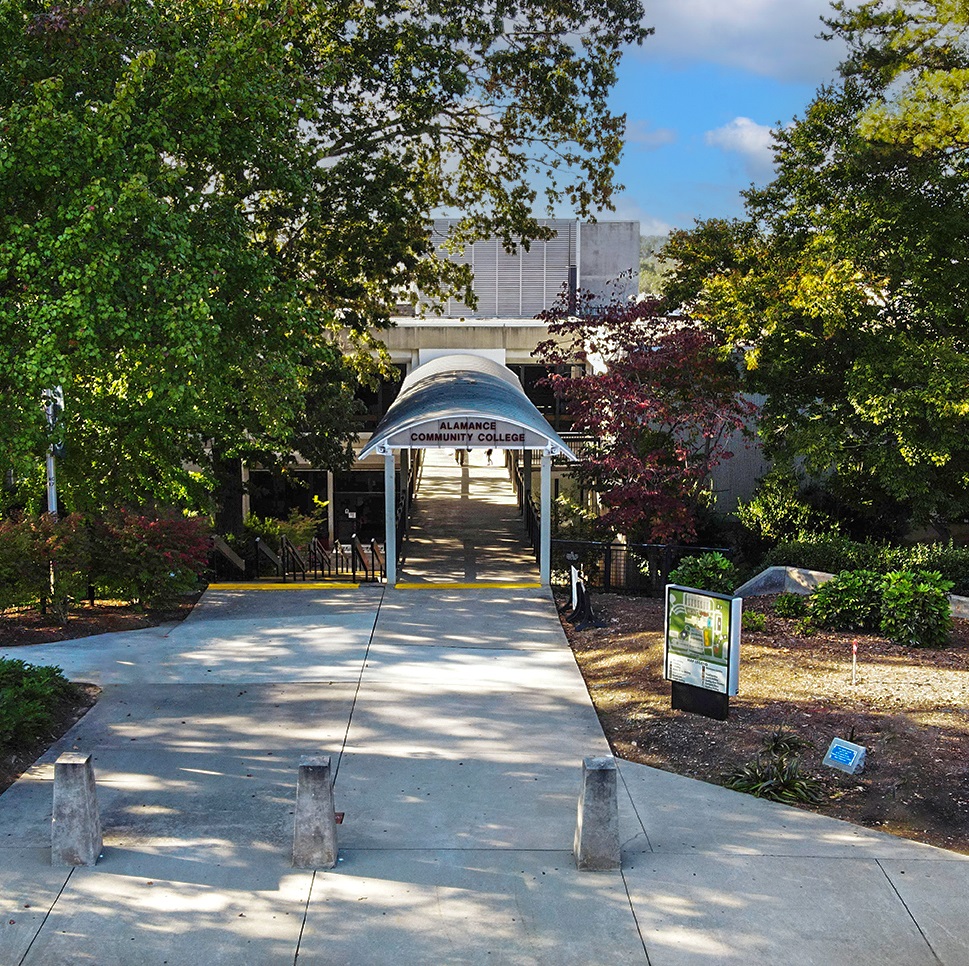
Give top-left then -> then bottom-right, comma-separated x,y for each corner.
665,584 -> 743,694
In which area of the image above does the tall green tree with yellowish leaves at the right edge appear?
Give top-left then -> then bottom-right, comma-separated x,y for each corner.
665,4 -> 969,533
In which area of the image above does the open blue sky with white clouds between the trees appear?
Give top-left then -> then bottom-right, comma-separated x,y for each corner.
600,0 -> 843,235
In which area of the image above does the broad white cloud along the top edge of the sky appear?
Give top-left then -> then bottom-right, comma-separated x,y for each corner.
641,0 -> 844,85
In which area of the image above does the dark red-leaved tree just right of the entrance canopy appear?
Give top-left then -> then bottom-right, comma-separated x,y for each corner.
535,296 -> 754,542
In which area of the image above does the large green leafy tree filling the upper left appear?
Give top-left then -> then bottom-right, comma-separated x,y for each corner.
0,0 -> 648,509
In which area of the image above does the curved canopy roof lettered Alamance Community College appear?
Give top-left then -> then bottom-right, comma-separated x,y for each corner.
360,354 -> 576,460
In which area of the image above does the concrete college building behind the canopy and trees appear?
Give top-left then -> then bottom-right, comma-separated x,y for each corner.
243,219 -> 761,545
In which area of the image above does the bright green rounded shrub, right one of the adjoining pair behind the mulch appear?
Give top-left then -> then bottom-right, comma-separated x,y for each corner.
880,570 -> 952,647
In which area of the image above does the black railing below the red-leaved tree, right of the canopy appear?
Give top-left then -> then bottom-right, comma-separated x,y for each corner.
552,540 -> 733,597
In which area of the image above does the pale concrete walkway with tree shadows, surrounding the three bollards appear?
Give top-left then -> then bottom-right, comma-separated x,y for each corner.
0,587 -> 969,966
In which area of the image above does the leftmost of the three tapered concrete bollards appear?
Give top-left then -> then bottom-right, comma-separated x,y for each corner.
51,751 -> 103,866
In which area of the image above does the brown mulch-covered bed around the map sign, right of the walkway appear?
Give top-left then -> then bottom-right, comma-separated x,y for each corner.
562,594 -> 969,854
